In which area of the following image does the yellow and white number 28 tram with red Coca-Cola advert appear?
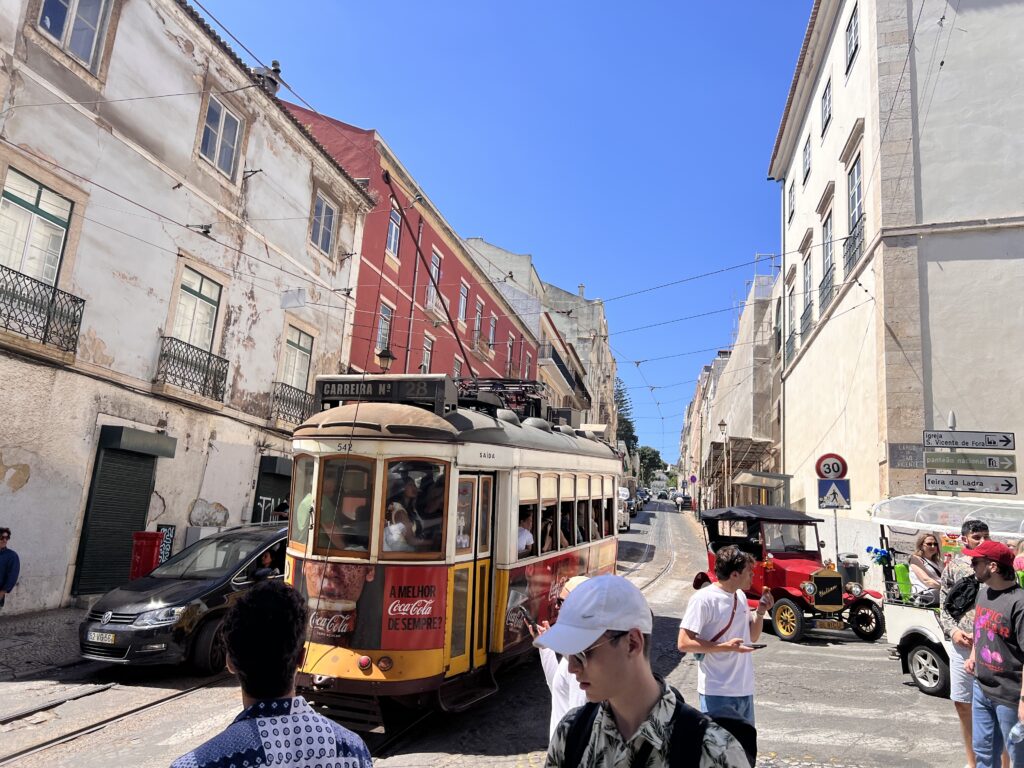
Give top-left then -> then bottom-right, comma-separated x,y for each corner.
285,375 -> 622,729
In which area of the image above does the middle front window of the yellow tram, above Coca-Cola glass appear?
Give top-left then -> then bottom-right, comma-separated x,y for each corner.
316,457 -> 374,554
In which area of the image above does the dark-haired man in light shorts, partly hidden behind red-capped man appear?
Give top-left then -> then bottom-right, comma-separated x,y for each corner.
939,520 -> 990,768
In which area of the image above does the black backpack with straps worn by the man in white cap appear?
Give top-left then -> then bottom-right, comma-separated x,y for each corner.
562,689 -> 758,768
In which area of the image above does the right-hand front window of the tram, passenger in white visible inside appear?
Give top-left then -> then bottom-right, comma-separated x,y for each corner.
383,459 -> 447,557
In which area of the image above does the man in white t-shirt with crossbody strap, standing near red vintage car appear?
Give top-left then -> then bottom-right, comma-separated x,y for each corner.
678,546 -> 774,725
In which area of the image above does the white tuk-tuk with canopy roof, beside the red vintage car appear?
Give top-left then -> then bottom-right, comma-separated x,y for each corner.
871,494 -> 1024,696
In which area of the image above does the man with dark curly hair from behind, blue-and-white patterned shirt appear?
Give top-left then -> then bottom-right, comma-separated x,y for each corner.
171,581 -> 372,768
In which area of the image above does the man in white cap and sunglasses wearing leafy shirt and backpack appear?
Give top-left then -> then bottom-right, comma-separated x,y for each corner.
534,575 -> 750,768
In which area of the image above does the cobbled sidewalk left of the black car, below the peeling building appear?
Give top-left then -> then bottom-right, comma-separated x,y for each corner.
0,608 -> 87,681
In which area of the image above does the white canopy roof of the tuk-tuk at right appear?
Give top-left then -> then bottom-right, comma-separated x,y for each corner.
871,494 -> 1024,537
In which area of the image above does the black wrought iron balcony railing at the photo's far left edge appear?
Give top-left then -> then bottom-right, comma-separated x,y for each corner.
0,265 -> 85,352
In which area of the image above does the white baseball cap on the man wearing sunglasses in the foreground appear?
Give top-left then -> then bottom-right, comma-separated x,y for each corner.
534,574 -> 653,655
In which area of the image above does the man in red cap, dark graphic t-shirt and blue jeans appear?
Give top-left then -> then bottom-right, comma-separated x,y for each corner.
964,541 -> 1024,768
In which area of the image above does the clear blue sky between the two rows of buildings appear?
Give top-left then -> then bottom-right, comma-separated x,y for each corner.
200,0 -> 811,462
